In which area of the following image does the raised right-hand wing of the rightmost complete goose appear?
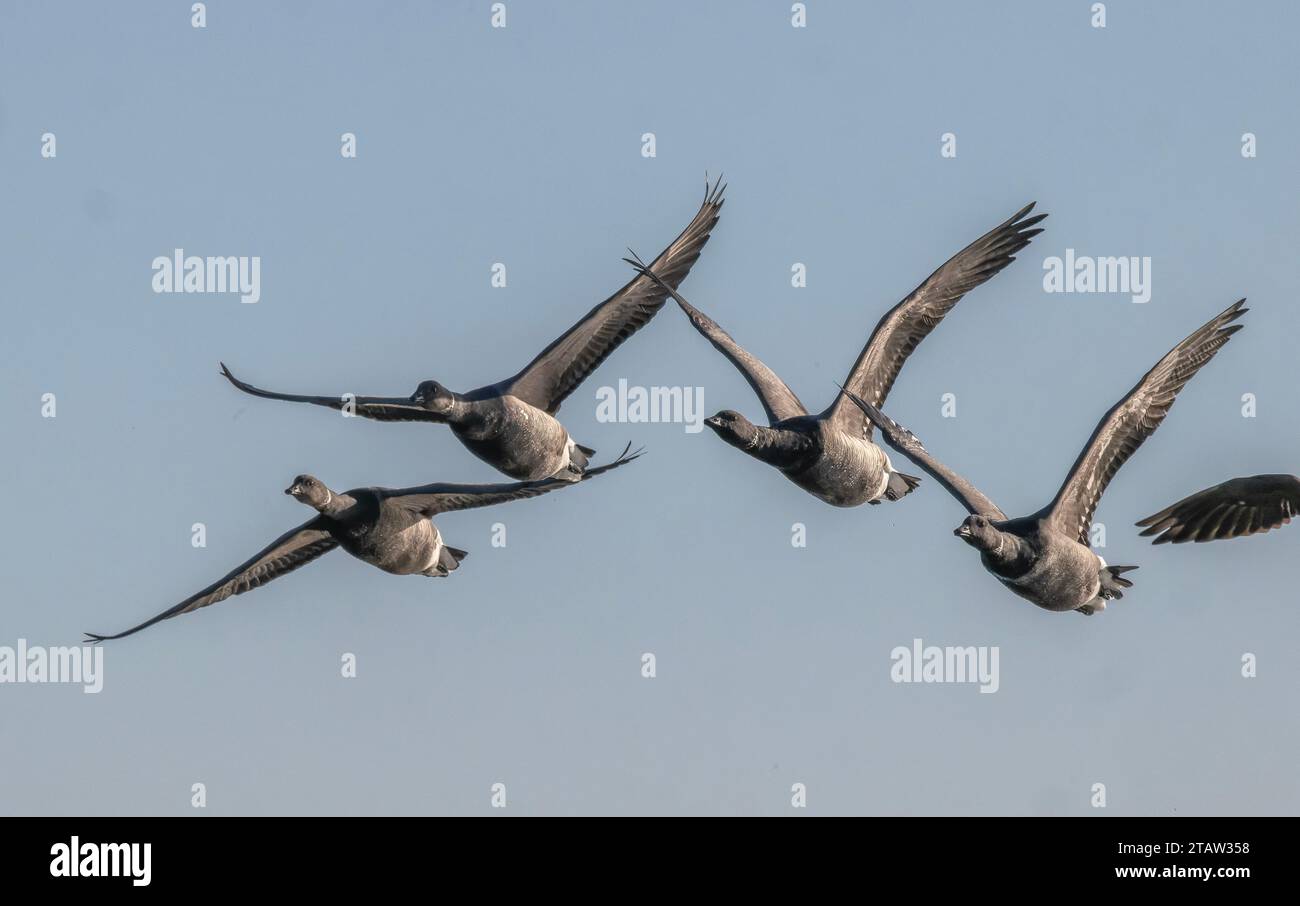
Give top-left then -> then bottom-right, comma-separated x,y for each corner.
1048,299 -> 1249,546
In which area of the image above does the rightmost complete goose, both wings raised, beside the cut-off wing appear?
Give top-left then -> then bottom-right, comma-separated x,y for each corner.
850,299 -> 1249,615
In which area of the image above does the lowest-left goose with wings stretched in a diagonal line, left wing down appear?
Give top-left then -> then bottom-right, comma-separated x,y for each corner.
85,445 -> 641,643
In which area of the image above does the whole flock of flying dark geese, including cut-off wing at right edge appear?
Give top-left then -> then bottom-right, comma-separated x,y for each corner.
86,181 -> 1300,643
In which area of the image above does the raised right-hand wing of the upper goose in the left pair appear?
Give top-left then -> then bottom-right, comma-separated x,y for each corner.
499,179 -> 727,415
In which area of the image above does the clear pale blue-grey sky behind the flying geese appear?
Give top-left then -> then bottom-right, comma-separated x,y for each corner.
0,0 -> 1300,815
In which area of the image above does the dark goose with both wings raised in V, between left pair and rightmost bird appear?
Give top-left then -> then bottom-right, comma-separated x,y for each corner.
624,203 -> 1047,507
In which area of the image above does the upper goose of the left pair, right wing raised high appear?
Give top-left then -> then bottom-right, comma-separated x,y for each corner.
221,179 -> 727,481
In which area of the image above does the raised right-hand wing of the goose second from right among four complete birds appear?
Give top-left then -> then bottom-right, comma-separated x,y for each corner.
828,203 -> 1047,437
